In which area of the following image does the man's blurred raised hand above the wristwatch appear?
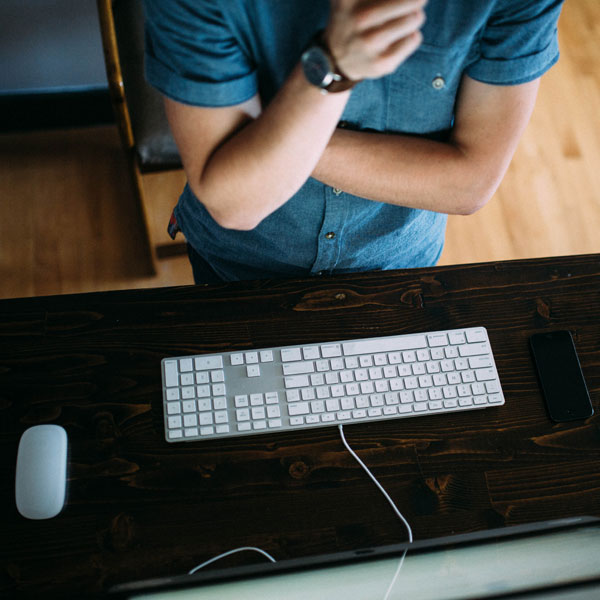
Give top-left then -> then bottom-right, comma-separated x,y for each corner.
325,0 -> 427,80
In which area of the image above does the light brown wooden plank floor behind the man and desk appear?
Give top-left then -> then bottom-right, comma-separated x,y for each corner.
0,0 -> 600,298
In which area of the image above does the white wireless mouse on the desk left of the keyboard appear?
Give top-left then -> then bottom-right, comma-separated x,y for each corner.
15,425 -> 67,519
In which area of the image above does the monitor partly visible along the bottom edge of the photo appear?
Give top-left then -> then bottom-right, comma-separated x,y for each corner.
111,517 -> 600,600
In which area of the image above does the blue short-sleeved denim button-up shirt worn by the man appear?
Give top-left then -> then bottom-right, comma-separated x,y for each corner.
145,0 -> 562,280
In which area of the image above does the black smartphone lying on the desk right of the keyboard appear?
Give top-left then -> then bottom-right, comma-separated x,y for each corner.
529,331 -> 594,422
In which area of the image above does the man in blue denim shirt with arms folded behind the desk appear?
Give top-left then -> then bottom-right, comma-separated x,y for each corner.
146,0 -> 562,283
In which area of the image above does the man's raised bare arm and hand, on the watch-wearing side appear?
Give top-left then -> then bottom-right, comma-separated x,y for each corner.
165,0 -> 425,229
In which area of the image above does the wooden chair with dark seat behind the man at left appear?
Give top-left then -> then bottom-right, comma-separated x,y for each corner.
97,0 -> 185,272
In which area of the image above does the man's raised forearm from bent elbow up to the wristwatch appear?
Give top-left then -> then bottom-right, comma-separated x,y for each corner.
191,68 -> 348,229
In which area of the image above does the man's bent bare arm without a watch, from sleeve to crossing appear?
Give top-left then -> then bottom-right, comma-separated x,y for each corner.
313,75 -> 539,214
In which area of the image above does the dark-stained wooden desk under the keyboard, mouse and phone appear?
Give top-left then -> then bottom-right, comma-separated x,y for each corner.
0,255 -> 600,598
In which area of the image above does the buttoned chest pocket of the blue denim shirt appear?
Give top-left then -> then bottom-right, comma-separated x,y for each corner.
386,43 -> 468,135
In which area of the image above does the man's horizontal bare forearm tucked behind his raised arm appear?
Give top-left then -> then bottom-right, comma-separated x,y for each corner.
313,129 -> 503,214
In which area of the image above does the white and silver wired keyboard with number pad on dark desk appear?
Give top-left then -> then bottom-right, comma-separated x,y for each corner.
161,327 -> 504,442
